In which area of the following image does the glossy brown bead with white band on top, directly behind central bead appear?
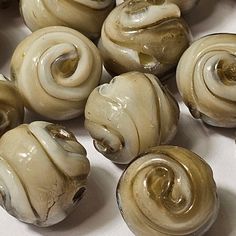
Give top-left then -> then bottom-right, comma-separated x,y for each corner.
98,0 -> 190,78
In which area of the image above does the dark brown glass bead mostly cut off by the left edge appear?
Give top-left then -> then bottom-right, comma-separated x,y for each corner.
0,74 -> 24,136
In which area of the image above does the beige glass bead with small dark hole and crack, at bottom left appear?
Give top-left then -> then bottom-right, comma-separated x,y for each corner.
0,122 -> 89,227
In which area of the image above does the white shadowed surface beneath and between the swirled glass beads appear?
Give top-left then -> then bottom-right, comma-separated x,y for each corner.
0,0 -> 236,236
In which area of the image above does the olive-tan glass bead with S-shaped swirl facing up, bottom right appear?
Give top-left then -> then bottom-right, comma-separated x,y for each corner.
117,146 -> 219,236
